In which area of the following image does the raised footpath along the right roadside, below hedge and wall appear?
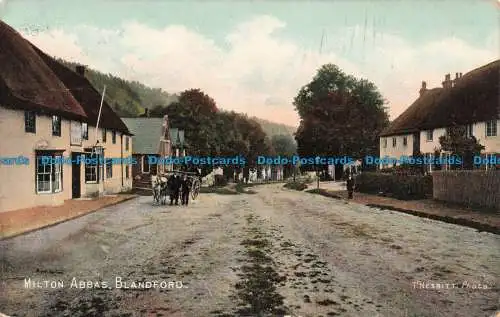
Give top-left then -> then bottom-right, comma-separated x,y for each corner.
312,186 -> 500,234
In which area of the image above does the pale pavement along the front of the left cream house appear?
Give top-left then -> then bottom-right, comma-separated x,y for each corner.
0,194 -> 137,240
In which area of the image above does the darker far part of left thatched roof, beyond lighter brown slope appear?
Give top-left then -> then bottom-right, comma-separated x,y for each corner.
33,46 -> 130,134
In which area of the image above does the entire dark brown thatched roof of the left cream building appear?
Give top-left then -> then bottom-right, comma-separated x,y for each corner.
0,21 -> 130,135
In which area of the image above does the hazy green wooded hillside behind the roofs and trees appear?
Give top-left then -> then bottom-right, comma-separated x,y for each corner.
59,59 -> 295,137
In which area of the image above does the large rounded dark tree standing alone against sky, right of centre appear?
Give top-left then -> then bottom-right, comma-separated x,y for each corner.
294,64 -> 389,173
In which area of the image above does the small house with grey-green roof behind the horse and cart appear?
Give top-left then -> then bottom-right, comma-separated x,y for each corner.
122,113 -> 172,188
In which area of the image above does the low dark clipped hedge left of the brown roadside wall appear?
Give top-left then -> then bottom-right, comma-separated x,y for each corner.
356,172 -> 432,200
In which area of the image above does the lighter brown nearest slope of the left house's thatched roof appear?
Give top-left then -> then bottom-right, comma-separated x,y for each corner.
0,20 -> 86,119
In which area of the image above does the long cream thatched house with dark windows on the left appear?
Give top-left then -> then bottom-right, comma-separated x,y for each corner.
0,21 -> 132,212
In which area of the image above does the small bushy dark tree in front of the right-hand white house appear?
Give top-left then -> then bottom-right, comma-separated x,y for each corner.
439,125 -> 484,169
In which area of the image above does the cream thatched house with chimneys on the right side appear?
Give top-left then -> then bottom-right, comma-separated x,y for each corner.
379,60 -> 500,171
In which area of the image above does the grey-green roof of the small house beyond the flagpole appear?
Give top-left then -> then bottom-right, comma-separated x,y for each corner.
122,118 -> 163,154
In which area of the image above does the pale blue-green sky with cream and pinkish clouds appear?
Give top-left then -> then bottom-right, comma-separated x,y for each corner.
0,0 -> 500,126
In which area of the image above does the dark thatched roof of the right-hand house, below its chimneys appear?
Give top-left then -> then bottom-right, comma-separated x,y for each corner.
381,60 -> 500,136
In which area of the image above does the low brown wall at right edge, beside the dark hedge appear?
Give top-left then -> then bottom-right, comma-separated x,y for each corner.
432,170 -> 500,210
